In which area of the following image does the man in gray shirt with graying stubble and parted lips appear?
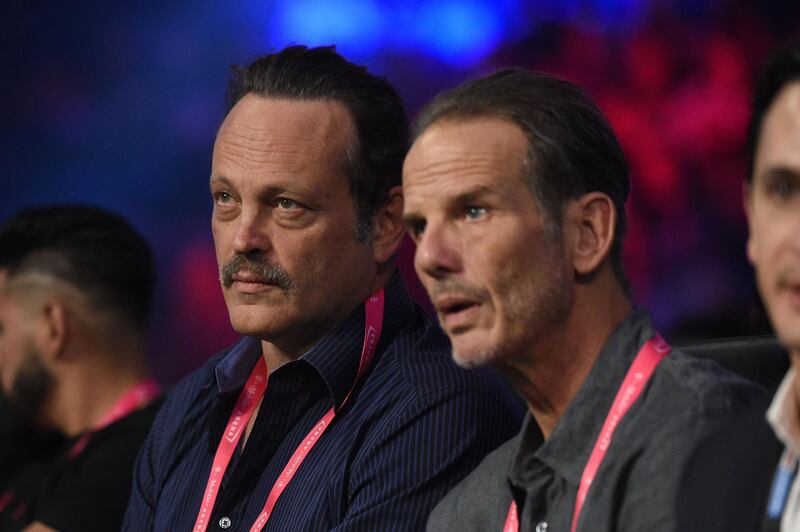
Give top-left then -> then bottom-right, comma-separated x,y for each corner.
403,69 -> 780,532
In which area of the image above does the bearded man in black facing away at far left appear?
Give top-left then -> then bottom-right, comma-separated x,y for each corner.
0,206 -> 160,532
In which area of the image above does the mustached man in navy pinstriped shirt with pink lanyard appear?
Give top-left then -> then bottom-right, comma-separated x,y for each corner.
124,46 -> 518,532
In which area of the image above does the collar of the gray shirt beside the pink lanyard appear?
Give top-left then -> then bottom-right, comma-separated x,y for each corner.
509,310 -> 655,488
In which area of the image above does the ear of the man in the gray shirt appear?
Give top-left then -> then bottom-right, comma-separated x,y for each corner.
568,192 -> 617,275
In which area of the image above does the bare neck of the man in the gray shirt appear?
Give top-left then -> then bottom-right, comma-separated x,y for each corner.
498,278 -> 631,438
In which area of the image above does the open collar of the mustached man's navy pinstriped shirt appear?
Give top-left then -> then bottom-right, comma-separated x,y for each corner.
214,271 -> 414,410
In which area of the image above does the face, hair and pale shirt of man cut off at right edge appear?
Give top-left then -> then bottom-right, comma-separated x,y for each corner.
744,39 -> 800,531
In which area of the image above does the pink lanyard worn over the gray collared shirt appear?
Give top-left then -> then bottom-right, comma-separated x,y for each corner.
503,334 -> 671,532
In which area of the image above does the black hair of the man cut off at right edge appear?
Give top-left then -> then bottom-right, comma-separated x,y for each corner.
747,39 -> 800,183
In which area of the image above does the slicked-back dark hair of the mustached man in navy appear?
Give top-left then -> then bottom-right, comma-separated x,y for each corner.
227,45 -> 409,242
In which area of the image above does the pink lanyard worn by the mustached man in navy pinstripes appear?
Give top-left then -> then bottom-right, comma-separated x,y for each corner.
193,289 -> 383,532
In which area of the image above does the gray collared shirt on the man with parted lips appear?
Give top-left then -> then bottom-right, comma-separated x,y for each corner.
428,311 -> 771,532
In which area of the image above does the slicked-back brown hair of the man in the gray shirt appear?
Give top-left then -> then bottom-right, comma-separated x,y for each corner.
415,68 -> 630,290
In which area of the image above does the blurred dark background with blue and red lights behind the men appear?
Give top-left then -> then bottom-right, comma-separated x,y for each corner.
0,0 -> 800,383
